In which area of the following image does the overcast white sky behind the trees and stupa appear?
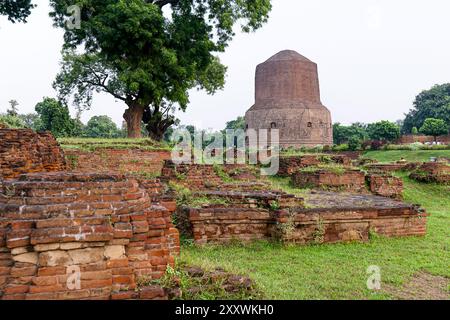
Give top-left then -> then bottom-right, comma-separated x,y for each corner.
0,0 -> 450,129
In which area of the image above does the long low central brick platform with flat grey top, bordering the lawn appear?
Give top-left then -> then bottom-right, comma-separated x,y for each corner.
179,192 -> 427,244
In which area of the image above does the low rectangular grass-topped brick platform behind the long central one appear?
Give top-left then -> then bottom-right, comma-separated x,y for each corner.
292,168 -> 366,193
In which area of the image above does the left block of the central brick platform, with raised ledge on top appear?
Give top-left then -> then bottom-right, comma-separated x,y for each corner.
177,191 -> 303,244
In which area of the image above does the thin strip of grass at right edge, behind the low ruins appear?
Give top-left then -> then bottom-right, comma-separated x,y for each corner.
364,150 -> 450,162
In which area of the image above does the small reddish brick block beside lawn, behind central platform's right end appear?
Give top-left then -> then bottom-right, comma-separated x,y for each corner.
366,173 -> 403,199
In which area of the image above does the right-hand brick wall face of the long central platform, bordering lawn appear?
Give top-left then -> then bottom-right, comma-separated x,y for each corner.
270,206 -> 426,244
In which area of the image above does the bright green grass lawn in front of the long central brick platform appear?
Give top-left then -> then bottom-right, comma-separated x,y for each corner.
181,174 -> 450,299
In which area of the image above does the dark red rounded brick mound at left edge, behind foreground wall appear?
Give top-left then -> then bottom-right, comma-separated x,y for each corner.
0,128 -> 66,179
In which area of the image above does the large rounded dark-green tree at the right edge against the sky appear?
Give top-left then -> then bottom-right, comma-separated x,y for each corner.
402,83 -> 450,133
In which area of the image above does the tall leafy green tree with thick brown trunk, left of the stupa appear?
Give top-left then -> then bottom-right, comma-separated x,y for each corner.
51,0 -> 271,140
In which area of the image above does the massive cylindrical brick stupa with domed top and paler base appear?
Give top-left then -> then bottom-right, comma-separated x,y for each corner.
245,50 -> 333,148
